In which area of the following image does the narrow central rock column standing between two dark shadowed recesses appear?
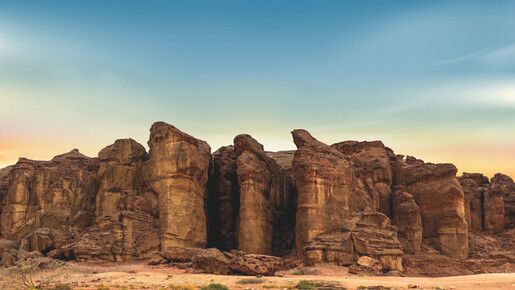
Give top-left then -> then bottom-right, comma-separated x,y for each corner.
234,135 -> 292,255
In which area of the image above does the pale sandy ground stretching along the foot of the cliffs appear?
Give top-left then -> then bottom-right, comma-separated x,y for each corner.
17,262 -> 515,290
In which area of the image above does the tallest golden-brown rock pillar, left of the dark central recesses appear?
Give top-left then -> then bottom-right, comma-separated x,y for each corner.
144,122 -> 211,248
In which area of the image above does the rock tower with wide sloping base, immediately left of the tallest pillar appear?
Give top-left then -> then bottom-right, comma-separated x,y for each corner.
64,139 -> 159,261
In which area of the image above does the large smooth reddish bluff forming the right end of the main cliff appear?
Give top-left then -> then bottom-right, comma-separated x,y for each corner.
394,160 -> 468,259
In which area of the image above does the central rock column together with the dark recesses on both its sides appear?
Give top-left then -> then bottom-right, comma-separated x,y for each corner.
209,135 -> 295,255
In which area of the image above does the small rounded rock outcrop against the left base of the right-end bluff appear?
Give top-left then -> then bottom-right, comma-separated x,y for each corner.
392,191 -> 423,254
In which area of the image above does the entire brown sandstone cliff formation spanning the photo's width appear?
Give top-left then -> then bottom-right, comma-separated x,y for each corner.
0,122 -> 515,272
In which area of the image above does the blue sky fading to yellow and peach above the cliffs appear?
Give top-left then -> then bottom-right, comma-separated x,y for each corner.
0,0 -> 515,177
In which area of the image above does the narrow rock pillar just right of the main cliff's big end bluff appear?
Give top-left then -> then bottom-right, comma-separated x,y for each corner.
458,173 -> 489,232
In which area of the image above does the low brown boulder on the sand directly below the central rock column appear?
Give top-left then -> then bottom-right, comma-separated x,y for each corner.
229,254 -> 283,276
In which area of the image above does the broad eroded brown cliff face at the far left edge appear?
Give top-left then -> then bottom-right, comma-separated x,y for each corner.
1,150 -> 98,242
